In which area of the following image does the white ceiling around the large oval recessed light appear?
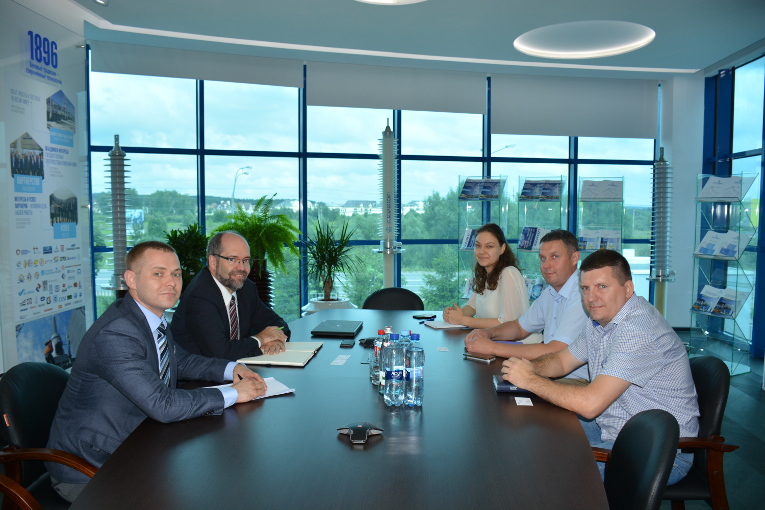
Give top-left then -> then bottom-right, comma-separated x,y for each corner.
38,0 -> 765,77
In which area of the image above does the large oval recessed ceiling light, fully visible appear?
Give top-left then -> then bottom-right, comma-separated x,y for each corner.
513,20 -> 656,59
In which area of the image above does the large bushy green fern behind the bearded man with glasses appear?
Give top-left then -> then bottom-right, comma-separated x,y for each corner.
214,193 -> 300,307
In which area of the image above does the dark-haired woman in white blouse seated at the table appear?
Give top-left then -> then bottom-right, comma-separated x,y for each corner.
443,223 -> 529,328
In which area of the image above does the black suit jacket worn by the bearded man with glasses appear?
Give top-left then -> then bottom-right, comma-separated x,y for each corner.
170,267 -> 290,361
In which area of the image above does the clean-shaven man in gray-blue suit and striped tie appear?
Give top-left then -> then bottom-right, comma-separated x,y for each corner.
47,241 -> 266,501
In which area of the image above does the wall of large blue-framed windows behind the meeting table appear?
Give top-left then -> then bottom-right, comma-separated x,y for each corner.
91,68 -> 653,320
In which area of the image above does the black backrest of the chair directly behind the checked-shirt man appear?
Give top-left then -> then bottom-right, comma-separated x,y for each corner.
690,356 -> 730,472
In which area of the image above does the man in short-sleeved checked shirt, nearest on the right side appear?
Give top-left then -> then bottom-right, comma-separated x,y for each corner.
502,250 -> 699,485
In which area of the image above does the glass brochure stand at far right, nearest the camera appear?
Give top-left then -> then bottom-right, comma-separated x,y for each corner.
689,174 -> 759,375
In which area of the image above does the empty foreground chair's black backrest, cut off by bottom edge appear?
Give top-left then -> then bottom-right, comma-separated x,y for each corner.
603,409 -> 680,510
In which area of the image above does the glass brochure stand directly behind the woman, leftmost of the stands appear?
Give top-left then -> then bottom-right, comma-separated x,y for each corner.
456,176 -> 508,305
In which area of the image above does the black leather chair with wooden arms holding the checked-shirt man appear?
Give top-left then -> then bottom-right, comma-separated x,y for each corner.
664,356 -> 738,510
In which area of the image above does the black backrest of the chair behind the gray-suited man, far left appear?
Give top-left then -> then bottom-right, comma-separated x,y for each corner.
0,362 -> 69,486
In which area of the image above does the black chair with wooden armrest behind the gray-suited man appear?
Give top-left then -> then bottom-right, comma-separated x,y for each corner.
0,362 -> 96,510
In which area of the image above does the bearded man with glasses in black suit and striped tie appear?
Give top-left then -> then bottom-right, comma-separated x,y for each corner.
170,231 -> 290,361
